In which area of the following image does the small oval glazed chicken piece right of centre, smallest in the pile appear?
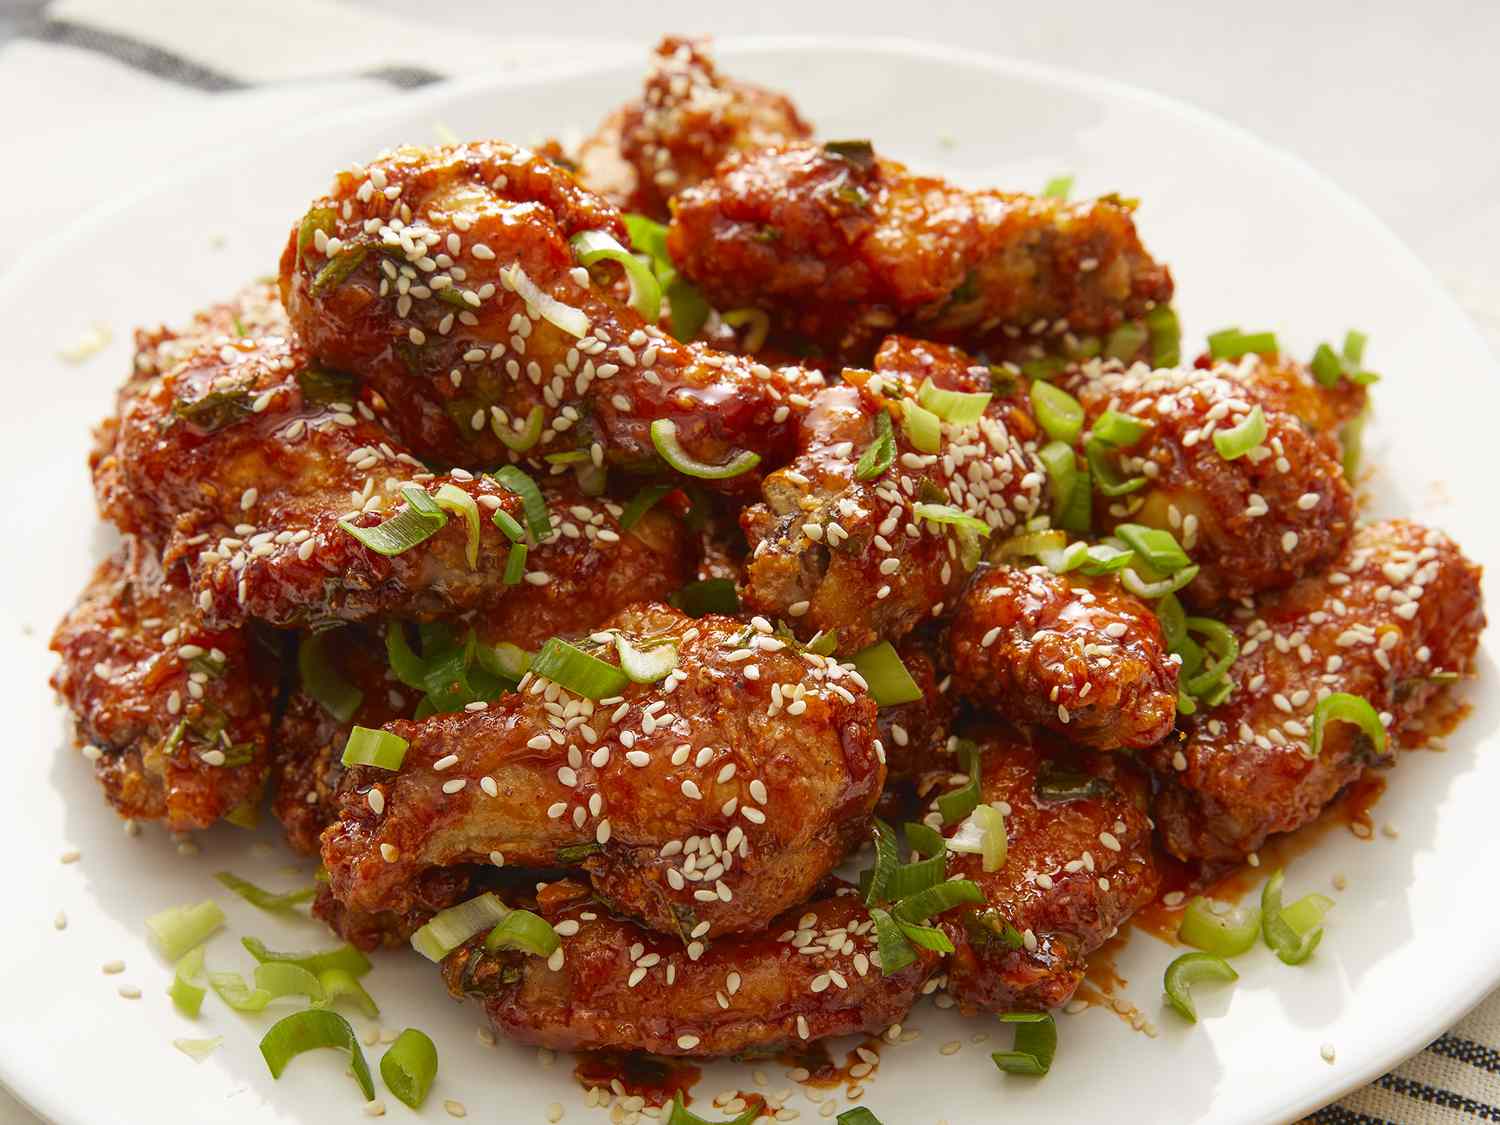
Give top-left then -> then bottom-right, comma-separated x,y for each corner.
948,566 -> 1181,750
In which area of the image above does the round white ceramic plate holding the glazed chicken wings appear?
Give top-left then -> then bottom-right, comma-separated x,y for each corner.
0,41 -> 1500,1125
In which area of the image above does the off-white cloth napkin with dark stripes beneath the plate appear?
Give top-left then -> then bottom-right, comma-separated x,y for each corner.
0,0 -> 1500,1125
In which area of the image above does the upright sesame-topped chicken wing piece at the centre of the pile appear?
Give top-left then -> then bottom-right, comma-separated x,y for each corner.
741,339 -> 1046,653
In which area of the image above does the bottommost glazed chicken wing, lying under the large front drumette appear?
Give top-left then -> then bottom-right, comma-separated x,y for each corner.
443,881 -> 938,1058
